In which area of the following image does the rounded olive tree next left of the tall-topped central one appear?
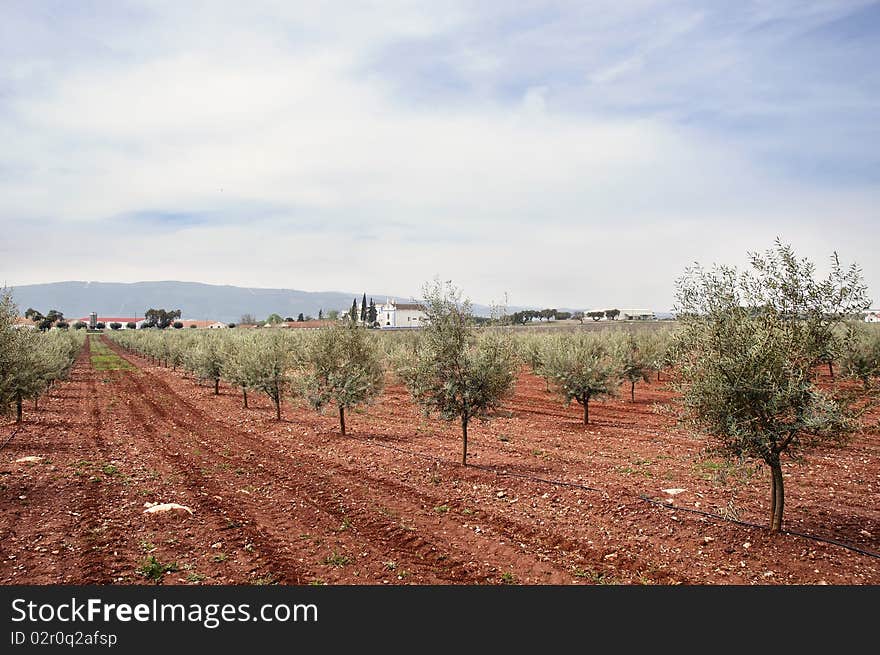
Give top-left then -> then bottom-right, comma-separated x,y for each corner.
302,323 -> 384,436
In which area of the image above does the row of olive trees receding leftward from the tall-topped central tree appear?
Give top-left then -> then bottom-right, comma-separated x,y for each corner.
108,283 -> 519,464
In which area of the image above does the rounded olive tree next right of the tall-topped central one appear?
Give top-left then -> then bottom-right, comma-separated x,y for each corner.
537,332 -> 620,425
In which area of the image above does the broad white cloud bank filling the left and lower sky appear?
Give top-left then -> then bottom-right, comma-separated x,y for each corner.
0,3 -> 880,309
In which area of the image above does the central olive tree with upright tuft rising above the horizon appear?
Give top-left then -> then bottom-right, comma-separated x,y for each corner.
398,281 -> 517,466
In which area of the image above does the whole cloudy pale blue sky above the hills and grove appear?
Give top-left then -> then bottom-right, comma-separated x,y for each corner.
0,0 -> 880,311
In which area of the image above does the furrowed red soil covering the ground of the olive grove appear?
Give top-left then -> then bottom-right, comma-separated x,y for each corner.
0,338 -> 880,584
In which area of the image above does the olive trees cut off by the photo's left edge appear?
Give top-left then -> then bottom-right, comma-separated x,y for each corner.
0,289 -> 85,422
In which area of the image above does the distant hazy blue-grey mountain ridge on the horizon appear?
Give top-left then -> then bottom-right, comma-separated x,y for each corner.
5,281 -> 562,323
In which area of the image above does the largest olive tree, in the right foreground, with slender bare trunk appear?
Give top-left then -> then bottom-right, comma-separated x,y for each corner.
676,240 -> 870,532
